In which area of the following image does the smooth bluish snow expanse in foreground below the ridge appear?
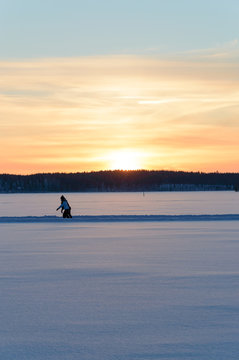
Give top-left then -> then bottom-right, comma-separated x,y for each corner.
0,221 -> 239,360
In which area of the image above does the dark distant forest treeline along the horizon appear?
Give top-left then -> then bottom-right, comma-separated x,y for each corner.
0,170 -> 239,193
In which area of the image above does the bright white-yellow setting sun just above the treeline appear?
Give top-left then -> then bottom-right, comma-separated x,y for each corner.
109,150 -> 141,170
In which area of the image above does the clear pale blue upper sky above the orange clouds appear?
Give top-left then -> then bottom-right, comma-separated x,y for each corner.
0,0 -> 239,59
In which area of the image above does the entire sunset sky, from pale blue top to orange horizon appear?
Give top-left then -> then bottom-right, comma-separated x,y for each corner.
0,0 -> 239,174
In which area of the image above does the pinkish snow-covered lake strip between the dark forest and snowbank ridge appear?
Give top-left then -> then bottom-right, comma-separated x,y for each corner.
0,191 -> 239,216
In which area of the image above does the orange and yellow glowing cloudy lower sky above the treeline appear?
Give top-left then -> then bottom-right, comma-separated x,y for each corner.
0,52 -> 239,174
